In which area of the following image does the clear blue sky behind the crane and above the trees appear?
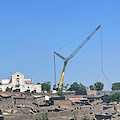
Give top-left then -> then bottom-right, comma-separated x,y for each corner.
0,0 -> 120,90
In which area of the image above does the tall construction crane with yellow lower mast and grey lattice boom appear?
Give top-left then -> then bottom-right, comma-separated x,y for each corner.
53,25 -> 101,90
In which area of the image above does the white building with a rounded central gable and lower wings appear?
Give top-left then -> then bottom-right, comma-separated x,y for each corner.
0,72 -> 41,93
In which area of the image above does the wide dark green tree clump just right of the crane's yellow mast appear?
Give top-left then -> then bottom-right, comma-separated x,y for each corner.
68,82 -> 86,91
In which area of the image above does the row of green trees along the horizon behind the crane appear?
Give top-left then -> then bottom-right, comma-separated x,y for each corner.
37,81 -> 120,92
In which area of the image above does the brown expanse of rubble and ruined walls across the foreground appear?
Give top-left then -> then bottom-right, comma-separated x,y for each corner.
0,95 -> 120,120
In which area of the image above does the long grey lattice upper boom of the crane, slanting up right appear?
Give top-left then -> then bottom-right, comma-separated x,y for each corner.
67,25 -> 101,60
